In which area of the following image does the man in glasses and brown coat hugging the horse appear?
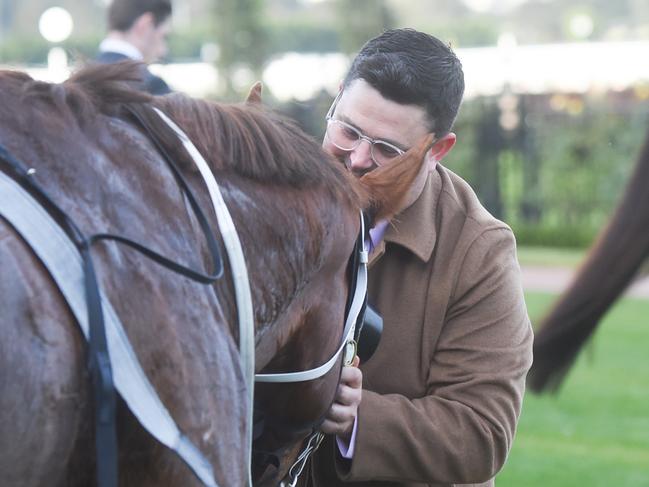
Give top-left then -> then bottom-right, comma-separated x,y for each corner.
306,29 -> 532,487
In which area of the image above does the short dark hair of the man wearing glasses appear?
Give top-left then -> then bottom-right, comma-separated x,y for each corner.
343,29 -> 464,138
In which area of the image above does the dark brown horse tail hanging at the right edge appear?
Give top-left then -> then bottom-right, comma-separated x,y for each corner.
528,125 -> 649,392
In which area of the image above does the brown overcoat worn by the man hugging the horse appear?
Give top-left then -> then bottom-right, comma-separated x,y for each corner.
310,165 -> 532,487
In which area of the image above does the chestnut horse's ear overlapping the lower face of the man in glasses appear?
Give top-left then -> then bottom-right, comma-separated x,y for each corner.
360,134 -> 435,222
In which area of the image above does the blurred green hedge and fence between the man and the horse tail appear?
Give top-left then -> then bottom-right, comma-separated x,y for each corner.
445,89 -> 649,247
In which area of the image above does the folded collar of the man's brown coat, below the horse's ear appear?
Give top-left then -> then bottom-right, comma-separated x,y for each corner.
369,168 -> 442,265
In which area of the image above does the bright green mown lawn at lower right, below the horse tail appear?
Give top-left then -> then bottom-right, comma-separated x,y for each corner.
496,293 -> 649,487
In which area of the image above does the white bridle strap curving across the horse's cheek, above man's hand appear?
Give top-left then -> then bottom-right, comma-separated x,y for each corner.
255,213 -> 367,383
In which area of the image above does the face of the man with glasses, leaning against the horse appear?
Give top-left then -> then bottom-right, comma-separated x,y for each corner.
322,79 -> 428,176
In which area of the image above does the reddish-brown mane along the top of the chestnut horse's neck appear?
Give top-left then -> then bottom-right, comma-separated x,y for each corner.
2,61 -> 361,206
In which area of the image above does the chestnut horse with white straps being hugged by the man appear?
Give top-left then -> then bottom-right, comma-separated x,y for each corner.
0,65 -> 432,487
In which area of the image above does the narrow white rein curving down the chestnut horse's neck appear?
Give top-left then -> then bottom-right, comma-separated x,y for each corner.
153,107 -> 255,485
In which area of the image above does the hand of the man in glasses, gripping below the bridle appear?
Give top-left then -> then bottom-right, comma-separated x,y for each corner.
321,356 -> 363,443
